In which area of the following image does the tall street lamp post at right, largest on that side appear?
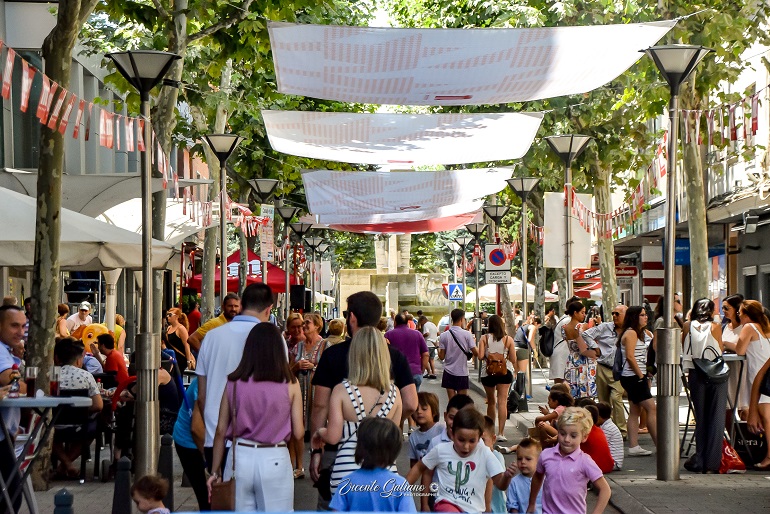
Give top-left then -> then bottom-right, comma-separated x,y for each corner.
645,45 -> 711,481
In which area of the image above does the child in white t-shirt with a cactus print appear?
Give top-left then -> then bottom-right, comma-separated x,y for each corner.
406,409 -> 516,512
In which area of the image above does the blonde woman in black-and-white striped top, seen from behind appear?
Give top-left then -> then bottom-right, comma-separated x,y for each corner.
311,327 -> 401,494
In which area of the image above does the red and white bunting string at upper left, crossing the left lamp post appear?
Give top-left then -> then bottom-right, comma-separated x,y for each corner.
0,40 -> 172,187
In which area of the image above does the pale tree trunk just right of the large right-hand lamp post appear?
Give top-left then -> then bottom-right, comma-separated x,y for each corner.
672,84 -> 711,302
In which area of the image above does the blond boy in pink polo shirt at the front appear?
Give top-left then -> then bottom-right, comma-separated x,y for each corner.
527,407 -> 611,514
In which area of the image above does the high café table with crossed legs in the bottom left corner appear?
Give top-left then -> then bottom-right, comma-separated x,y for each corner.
0,396 -> 92,514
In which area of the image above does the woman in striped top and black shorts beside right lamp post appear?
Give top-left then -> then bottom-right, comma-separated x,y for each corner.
620,307 -> 658,457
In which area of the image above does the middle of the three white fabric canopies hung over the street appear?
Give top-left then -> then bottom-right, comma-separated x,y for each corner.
262,110 -> 543,165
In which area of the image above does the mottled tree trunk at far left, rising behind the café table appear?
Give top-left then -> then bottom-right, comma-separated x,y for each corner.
27,0 -> 96,491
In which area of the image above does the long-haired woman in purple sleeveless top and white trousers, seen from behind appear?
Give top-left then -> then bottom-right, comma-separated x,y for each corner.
208,323 -> 305,506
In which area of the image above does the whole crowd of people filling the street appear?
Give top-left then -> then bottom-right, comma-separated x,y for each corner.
0,284 -> 770,512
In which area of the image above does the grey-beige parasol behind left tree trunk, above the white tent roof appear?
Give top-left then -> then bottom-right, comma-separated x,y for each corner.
0,168 -> 211,218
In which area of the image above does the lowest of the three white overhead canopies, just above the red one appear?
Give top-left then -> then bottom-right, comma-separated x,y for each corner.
302,168 -> 513,217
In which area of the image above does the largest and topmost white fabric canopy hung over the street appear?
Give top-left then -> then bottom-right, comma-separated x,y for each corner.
268,21 -> 676,105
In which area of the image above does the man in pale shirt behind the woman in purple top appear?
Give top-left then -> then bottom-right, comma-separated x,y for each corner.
195,283 -> 276,466
